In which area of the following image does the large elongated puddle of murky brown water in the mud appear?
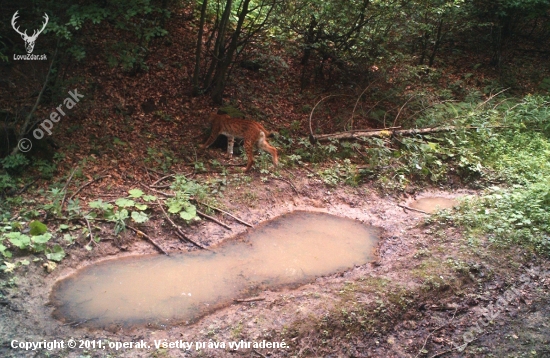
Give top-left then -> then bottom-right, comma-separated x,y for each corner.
51,211 -> 377,326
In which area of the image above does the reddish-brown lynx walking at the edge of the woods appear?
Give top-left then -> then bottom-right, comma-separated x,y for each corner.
203,113 -> 278,172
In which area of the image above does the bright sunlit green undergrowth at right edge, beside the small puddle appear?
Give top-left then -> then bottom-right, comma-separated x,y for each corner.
426,96 -> 550,255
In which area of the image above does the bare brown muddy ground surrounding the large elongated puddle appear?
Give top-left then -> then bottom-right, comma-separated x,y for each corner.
0,168 -> 550,357
